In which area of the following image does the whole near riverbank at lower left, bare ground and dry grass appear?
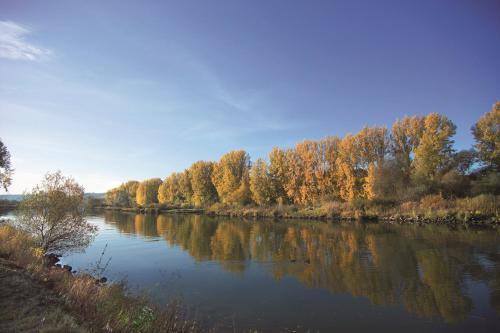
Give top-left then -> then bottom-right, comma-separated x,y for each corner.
0,225 -> 198,332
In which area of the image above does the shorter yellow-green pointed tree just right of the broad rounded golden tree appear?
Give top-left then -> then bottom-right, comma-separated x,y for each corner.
250,158 -> 276,205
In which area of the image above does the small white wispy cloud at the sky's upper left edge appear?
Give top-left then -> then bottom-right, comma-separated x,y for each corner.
0,21 -> 51,61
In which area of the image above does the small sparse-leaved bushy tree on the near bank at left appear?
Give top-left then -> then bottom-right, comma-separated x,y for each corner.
17,171 -> 97,254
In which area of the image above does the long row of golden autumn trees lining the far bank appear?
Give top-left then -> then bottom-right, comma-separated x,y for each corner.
106,102 -> 500,207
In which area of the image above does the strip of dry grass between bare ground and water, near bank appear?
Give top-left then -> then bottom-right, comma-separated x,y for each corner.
0,225 -> 198,332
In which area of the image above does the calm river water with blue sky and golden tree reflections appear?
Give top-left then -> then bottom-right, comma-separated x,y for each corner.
14,212 -> 500,332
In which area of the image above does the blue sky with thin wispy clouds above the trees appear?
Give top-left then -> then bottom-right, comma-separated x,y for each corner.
0,0 -> 500,193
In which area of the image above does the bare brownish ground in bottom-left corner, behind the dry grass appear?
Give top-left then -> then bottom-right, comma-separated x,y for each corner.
0,258 -> 87,333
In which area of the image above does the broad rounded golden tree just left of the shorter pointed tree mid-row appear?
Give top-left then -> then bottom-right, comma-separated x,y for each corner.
212,150 -> 250,203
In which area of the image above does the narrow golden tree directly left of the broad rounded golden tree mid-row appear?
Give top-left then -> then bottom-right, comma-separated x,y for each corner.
189,161 -> 217,207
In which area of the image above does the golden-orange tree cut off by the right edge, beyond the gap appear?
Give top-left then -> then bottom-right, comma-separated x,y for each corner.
472,101 -> 500,170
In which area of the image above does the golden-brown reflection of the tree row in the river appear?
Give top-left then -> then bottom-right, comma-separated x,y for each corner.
105,211 -> 500,322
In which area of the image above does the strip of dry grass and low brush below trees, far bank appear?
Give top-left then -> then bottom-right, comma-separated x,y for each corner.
206,195 -> 500,224
